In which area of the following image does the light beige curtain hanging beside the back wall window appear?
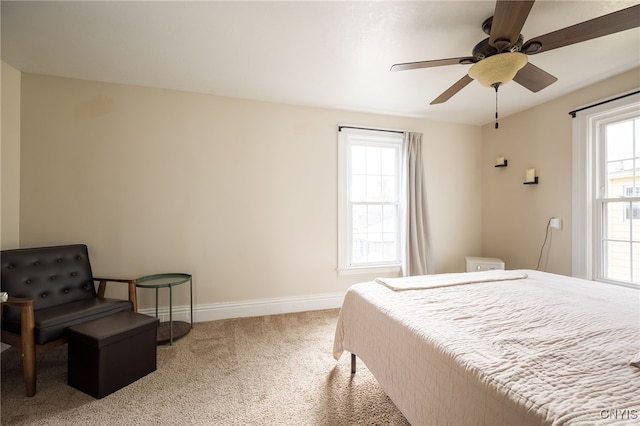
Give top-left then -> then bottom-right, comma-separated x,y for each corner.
402,132 -> 435,276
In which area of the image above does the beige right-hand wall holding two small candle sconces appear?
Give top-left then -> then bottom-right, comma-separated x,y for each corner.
482,69 -> 640,275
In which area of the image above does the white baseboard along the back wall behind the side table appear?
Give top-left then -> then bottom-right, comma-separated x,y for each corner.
138,293 -> 344,322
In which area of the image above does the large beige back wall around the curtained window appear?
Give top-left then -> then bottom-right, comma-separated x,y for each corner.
20,74 -> 481,308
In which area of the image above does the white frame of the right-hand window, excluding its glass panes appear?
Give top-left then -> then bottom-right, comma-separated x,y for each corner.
572,93 -> 640,288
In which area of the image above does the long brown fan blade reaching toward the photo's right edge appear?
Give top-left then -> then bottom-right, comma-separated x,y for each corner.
522,4 -> 640,55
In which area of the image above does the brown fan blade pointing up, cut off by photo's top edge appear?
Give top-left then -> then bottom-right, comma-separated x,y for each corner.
489,0 -> 534,50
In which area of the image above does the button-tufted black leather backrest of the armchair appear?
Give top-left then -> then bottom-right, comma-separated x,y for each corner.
0,244 -> 96,315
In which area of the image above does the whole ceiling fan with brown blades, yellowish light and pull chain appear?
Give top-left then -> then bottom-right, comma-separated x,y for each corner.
391,0 -> 640,120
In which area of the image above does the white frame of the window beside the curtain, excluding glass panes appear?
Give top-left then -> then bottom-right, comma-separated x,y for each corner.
337,126 -> 406,275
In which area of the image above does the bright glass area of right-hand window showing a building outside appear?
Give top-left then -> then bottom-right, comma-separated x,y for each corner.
600,118 -> 640,284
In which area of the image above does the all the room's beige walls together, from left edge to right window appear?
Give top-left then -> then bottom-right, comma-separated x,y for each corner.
10,67 -> 640,308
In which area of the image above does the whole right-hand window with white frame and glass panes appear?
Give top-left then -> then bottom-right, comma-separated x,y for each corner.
573,94 -> 640,287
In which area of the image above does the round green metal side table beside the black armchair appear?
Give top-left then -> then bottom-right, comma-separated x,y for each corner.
136,273 -> 193,345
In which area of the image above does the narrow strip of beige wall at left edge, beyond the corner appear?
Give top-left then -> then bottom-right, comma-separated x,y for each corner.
0,62 -> 21,249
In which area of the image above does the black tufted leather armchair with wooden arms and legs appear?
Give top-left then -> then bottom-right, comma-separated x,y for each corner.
0,244 -> 138,396
